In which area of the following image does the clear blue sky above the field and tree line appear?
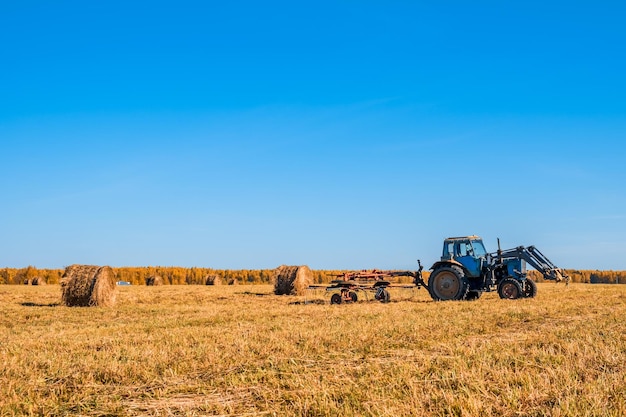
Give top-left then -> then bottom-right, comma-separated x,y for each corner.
0,0 -> 626,269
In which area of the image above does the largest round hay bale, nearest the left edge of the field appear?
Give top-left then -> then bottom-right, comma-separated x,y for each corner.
61,265 -> 116,307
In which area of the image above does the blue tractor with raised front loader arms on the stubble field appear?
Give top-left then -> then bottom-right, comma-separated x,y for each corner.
428,236 -> 569,301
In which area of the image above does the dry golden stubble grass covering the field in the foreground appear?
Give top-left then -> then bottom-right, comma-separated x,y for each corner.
0,283 -> 626,417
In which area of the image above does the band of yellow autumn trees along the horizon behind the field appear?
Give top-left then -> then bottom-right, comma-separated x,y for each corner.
0,266 -> 626,285
